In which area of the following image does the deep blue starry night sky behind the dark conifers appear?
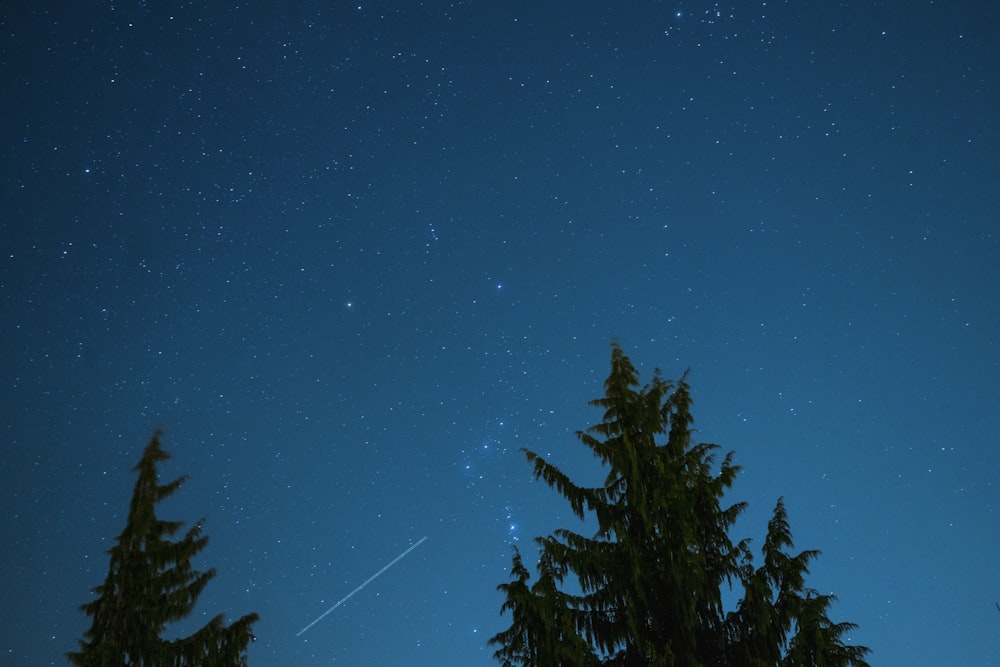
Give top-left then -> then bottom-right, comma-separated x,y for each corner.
0,0 -> 1000,667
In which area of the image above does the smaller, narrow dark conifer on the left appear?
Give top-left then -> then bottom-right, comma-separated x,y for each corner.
67,431 -> 259,667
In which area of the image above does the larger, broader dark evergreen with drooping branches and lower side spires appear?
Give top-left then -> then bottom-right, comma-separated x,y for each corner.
490,345 -> 869,667
